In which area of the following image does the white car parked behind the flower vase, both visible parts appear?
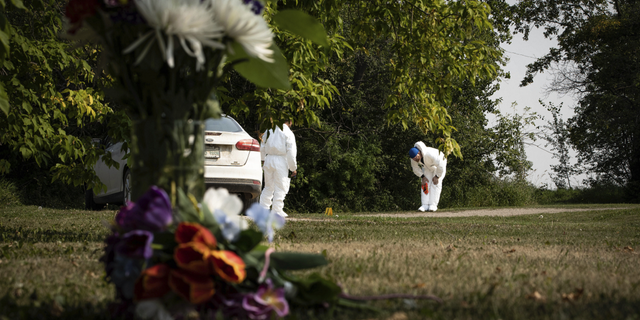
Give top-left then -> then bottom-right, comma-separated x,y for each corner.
85,115 -> 262,210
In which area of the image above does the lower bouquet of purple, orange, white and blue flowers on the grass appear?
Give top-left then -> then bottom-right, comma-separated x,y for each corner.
101,187 -> 342,319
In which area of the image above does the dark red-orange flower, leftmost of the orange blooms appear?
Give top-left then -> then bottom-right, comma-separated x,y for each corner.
133,264 -> 171,301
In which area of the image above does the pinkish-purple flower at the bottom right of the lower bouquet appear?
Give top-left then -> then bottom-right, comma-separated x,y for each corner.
242,279 -> 289,319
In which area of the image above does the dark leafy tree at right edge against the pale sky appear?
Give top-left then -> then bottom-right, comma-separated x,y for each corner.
514,0 -> 640,199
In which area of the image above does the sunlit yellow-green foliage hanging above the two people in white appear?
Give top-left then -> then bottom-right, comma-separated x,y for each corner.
222,0 -> 499,156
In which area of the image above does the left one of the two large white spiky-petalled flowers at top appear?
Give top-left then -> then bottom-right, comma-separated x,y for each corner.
123,0 -> 224,70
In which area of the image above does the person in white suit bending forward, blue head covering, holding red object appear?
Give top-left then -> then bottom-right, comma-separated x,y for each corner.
409,141 -> 447,212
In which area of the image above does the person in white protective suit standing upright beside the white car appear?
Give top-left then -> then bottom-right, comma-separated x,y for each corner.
260,121 -> 298,217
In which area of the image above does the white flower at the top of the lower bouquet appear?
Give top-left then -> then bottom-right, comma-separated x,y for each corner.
202,188 -> 249,241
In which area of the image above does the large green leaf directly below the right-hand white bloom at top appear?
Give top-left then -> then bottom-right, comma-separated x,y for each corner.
229,42 -> 291,90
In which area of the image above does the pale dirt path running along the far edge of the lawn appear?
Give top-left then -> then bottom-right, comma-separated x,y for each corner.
287,208 -> 624,221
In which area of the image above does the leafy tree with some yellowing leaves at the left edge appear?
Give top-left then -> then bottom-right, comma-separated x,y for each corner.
0,0 -> 127,198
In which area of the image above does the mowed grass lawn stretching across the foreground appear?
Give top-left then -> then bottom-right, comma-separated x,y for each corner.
0,205 -> 640,320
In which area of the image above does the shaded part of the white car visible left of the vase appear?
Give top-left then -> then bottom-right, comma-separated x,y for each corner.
84,139 -> 131,210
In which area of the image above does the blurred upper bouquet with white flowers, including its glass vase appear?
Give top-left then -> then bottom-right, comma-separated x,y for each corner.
65,0 -> 328,201
